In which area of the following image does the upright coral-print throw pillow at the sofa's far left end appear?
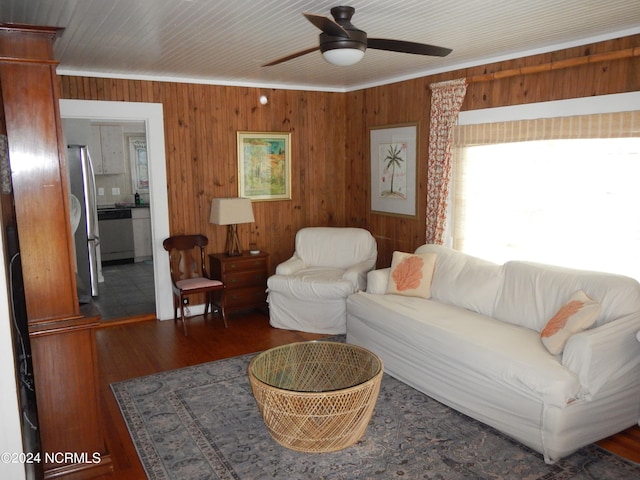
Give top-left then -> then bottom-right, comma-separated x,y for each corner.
387,252 -> 436,298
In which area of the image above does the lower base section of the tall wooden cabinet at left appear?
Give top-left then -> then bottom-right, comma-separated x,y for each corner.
30,317 -> 113,479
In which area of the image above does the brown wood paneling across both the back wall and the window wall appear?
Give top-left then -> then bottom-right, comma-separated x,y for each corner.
61,35 -> 640,269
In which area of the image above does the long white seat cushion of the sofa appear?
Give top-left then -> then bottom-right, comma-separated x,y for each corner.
347,292 -> 582,407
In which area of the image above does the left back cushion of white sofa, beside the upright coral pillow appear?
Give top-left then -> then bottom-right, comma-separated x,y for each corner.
415,244 -> 503,317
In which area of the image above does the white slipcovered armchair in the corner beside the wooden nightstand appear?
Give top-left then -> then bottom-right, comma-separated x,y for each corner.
267,227 -> 378,334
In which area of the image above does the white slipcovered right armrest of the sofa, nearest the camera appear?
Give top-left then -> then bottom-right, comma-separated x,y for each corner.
562,313 -> 640,398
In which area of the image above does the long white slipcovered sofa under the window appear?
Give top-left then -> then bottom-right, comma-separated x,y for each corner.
347,245 -> 640,463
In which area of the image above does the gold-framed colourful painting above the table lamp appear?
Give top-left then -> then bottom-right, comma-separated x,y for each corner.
237,132 -> 291,201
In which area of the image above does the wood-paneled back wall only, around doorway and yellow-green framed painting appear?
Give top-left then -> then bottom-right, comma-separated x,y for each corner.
60,76 -> 348,268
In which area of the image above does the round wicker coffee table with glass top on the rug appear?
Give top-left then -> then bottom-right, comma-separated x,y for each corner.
248,341 -> 383,452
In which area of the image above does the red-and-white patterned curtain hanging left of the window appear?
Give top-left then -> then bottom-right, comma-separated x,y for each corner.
426,78 -> 467,245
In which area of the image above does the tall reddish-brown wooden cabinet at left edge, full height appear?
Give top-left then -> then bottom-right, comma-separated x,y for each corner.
0,24 -> 112,479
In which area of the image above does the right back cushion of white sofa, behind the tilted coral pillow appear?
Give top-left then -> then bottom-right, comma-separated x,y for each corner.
498,261 -> 640,332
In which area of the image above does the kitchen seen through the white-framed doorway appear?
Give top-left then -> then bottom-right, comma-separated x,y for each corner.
63,119 -> 155,321
